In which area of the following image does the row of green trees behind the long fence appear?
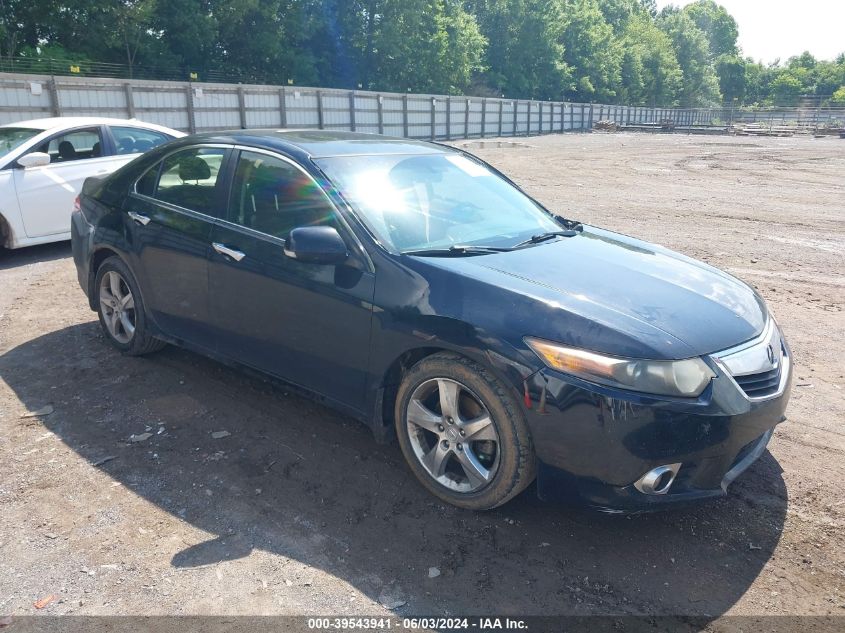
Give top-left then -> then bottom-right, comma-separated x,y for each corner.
0,0 -> 845,106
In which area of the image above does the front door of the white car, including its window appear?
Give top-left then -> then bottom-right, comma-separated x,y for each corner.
13,126 -> 120,237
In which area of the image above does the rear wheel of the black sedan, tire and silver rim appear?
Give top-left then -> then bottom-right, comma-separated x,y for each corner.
94,256 -> 166,356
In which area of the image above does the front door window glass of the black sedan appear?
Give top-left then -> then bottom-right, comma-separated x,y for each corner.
229,152 -> 336,239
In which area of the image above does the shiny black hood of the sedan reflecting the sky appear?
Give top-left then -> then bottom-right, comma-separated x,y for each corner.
408,227 -> 768,359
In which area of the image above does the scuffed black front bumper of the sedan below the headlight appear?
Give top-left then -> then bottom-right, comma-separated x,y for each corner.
526,328 -> 792,512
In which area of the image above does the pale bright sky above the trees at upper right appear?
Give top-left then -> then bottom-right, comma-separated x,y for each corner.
657,0 -> 845,63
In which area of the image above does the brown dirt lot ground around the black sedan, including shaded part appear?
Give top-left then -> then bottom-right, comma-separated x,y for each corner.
0,134 -> 845,617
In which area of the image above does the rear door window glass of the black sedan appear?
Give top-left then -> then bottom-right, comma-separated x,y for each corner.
148,147 -> 226,215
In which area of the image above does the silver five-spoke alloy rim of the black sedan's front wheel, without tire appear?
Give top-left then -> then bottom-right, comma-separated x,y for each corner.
405,378 -> 500,493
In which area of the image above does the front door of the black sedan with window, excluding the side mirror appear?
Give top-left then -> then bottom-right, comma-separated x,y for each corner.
209,150 -> 374,411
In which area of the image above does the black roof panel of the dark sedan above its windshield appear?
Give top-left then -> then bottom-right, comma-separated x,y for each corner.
183,129 -> 453,158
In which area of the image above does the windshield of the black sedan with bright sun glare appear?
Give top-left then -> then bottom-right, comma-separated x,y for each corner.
316,154 -> 560,251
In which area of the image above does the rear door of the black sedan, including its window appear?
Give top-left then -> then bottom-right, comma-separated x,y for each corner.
124,146 -> 230,350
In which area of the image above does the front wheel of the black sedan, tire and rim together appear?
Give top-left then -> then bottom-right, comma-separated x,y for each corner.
394,353 -> 536,510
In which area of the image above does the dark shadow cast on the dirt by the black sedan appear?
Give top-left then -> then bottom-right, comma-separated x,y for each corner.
0,322 -> 787,617
